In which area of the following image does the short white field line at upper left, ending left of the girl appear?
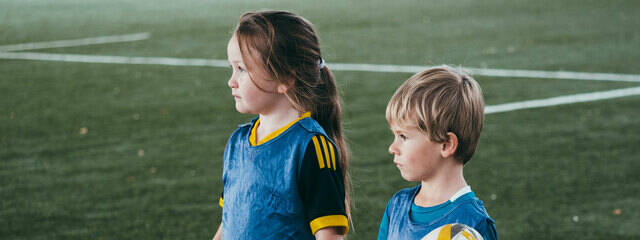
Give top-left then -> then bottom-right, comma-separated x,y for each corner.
0,32 -> 150,52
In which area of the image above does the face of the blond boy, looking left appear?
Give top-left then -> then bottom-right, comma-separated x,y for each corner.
389,124 -> 444,181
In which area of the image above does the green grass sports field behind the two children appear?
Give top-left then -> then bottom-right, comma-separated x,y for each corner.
0,0 -> 640,239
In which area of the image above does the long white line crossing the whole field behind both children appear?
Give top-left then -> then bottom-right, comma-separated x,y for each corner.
0,52 -> 640,82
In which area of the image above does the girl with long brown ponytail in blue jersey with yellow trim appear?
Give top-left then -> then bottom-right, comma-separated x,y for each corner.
214,11 -> 350,240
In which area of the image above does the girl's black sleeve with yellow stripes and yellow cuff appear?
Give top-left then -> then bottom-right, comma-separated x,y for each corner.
298,135 -> 349,234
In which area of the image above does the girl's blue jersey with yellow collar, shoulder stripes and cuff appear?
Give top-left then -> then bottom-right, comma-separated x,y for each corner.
221,114 -> 348,240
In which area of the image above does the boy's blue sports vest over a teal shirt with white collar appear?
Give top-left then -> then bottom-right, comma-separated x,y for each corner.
378,185 -> 497,240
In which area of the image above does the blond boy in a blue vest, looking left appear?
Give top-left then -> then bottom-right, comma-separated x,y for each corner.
378,66 -> 497,240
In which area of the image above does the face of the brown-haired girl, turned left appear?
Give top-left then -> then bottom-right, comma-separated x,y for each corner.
227,34 -> 283,114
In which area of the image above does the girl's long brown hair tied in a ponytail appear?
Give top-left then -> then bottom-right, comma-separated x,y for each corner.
234,11 -> 351,225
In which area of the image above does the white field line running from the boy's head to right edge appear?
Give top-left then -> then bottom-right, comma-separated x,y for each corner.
484,87 -> 640,114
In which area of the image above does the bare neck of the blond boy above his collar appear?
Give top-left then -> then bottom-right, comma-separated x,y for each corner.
413,163 -> 467,207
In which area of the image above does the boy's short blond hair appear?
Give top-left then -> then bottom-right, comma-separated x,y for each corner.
386,66 -> 484,164
